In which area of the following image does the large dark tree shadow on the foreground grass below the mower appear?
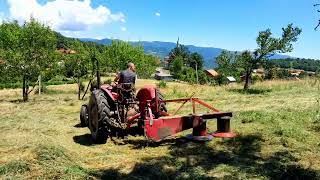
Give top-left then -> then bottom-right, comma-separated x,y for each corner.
90,133 -> 320,179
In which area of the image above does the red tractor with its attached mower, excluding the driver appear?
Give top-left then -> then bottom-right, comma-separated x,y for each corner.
80,60 -> 235,143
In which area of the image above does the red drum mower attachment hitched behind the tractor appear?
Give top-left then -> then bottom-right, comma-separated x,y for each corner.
140,95 -> 236,141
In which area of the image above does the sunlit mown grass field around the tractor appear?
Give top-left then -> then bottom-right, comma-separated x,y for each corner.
0,79 -> 320,179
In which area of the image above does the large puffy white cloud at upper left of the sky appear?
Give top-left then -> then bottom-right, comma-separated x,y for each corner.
7,0 -> 125,31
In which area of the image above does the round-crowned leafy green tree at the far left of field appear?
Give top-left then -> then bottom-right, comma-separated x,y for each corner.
0,18 -> 56,101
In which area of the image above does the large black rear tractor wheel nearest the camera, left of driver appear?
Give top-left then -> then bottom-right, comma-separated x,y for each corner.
89,89 -> 110,143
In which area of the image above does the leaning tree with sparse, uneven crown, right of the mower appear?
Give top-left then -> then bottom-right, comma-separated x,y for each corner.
240,24 -> 301,90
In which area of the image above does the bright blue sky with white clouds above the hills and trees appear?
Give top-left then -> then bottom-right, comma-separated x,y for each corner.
0,0 -> 320,59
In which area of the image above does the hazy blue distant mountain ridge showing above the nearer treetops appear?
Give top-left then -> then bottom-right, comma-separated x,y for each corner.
80,38 -> 291,68
